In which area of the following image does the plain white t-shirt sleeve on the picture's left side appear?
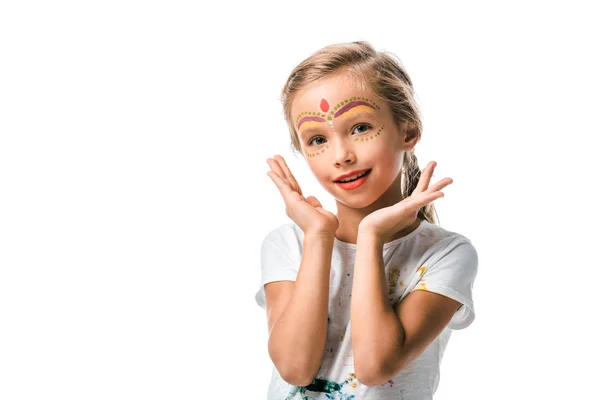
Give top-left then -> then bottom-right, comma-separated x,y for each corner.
254,236 -> 299,309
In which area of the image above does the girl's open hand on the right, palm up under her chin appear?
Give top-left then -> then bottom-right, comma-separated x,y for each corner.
358,161 -> 452,242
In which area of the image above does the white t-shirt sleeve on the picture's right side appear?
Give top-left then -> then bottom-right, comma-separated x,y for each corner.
412,241 -> 478,330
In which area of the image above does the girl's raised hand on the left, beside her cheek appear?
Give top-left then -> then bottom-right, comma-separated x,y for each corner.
267,155 -> 339,236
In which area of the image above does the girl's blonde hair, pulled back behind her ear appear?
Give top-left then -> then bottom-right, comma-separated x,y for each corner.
281,41 -> 438,228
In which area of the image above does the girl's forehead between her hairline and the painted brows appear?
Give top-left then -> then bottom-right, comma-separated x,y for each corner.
292,75 -> 376,121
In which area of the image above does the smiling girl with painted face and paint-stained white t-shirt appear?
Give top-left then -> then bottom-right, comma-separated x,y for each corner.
256,42 -> 477,400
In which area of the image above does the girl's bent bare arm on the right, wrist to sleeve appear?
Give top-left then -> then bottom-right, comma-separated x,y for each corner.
350,232 -> 461,386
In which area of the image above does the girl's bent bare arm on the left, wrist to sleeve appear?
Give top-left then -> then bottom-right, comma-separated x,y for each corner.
265,234 -> 334,386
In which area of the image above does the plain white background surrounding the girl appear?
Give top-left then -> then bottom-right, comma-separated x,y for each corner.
0,1 -> 600,400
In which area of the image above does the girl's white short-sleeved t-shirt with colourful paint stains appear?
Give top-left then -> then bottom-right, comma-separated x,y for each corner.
255,221 -> 478,400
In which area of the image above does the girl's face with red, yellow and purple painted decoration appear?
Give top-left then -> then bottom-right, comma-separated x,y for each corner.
292,75 -> 416,208
